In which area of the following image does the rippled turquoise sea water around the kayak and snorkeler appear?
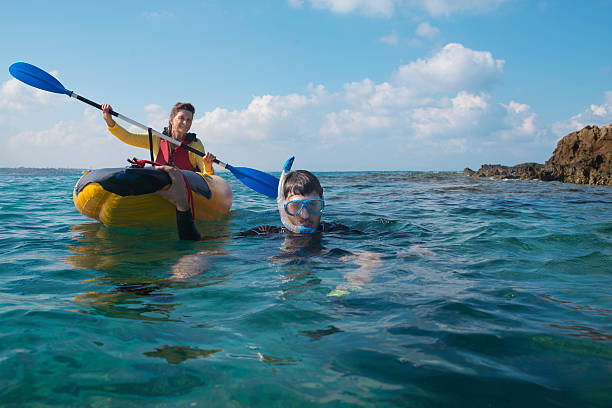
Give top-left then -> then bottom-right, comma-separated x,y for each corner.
0,172 -> 612,407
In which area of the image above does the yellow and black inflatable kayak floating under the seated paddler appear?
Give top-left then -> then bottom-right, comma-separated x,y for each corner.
72,167 -> 233,226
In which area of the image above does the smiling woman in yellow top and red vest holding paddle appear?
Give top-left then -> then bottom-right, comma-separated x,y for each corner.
102,102 -> 215,175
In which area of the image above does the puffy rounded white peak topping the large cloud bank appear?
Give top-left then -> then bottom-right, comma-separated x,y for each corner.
393,43 -> 504,93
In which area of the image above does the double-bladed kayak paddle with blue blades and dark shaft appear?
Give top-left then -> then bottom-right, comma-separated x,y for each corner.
9,62 -> 278,198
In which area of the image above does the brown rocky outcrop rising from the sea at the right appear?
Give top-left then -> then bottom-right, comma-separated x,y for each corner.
463,124 -> 612,185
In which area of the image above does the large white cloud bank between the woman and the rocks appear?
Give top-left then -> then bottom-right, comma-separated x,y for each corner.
189,44 -> 537,168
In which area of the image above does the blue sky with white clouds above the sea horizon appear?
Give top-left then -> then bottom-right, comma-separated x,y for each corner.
0,0 -> 612,171
